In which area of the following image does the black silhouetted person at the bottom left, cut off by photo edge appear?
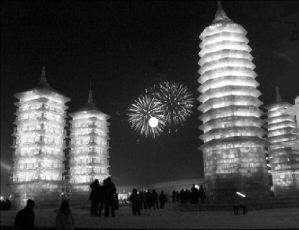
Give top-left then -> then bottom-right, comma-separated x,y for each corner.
15,199 -> 34,229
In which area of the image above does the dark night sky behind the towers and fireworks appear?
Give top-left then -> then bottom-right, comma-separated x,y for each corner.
1,0 -> 299,197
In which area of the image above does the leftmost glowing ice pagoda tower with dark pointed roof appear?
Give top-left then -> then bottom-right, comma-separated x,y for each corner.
11,67 -> 70,207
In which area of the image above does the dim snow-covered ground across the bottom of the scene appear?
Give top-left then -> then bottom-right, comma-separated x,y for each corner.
0,204 -> 299,229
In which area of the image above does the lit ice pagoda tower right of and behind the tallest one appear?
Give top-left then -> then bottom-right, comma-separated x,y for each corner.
267,88 -> 299,196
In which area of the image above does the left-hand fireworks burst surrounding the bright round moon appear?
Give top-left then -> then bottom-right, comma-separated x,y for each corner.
128,94 -> 165,137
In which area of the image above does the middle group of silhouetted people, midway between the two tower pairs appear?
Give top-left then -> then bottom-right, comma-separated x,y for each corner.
129,188 -> 167,216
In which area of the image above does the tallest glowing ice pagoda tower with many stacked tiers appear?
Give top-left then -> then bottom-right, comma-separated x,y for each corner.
198,2 -> 268,200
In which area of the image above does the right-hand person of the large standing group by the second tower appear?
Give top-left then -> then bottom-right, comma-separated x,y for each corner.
104,177 -> 116,217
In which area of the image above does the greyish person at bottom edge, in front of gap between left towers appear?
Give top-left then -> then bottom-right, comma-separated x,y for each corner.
55,200 -> 74,230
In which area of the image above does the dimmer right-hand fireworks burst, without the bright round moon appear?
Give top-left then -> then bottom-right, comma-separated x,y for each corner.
152,82 -> 194,127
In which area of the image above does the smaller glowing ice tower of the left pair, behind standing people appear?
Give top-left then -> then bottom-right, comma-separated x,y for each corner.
70,91 -> 109,192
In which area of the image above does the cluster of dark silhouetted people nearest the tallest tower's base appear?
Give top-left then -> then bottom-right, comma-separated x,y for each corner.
172,184 -> 206,204
